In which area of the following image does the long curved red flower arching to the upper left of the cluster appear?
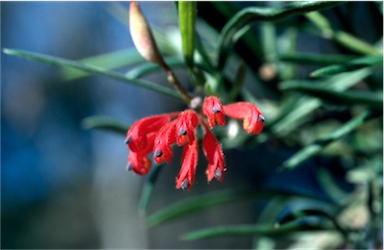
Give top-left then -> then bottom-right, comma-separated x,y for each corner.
125,113 -> 178,152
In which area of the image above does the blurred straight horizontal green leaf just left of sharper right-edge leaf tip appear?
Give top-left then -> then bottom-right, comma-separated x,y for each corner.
278,53 -> 356,65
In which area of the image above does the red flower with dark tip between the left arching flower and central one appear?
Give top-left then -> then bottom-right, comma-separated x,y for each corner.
153,120 -> 176,164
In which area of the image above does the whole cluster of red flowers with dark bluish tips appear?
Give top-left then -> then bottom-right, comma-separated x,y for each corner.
125,96 -> 264,190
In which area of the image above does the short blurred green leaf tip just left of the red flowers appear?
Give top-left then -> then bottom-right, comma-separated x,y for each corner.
82,116 -> 130,135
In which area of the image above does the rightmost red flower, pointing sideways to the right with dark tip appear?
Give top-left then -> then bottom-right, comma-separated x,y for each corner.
223,102 -> 265,135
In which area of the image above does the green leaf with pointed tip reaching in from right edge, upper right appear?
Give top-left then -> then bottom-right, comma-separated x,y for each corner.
310,55 -> 383,77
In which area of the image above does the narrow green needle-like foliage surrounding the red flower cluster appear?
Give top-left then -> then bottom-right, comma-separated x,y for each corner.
3,1 -> 383,248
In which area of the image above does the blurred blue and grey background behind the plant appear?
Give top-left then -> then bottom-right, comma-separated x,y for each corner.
1,2 -> 382,249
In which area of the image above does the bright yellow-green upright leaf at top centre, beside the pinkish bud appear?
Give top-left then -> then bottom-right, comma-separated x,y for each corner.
178,1 -> 197,69
